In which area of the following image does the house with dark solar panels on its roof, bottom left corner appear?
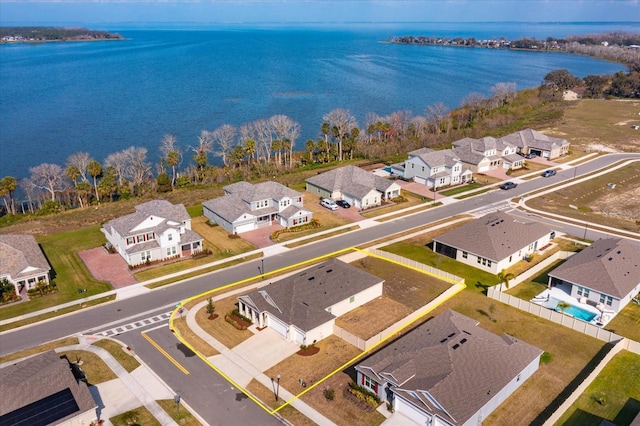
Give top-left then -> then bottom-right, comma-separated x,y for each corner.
0,351 -> 98,426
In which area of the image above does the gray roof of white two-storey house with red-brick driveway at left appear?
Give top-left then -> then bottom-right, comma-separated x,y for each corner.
105,200 -> 190,237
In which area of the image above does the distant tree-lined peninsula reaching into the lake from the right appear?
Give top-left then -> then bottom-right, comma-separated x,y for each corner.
389,32 -> 640,72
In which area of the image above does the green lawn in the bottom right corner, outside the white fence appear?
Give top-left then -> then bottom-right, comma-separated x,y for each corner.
557,351 -> 640,426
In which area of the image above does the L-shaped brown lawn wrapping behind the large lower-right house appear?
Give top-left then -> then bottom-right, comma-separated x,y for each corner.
432,290 -> 606,425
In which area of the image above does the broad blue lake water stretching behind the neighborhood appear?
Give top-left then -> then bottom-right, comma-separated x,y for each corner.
0,23 -> 633,178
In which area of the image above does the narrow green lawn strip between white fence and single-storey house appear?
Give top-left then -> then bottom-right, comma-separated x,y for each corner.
381,241 -> 498,293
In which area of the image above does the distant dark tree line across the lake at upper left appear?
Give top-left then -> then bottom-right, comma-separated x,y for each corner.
0,27 -> 122,43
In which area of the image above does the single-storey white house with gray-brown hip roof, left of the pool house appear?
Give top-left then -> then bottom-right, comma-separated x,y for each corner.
433,212 -> 555,274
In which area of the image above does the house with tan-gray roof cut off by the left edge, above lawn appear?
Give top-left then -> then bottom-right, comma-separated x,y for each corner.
0,234 -> 51,295
